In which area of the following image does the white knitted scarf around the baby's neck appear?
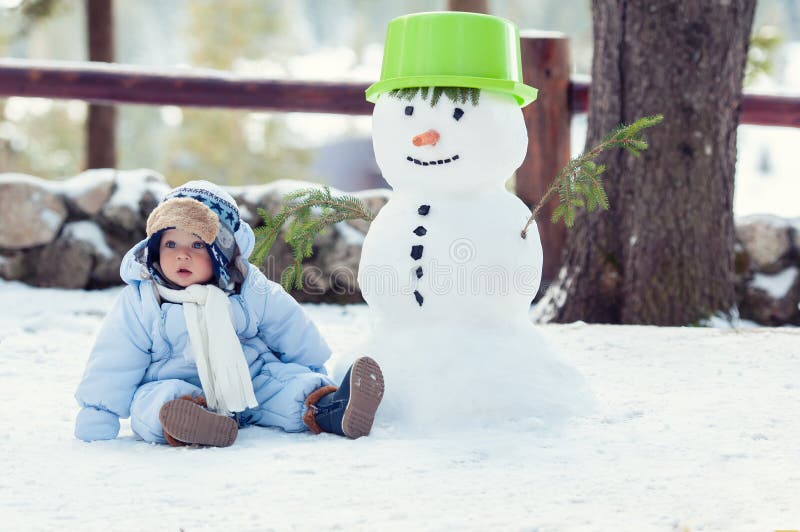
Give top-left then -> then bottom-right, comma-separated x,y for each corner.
156,284 -> 258,415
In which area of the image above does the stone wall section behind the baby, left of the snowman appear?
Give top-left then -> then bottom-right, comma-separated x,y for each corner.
0,170 -> 389,303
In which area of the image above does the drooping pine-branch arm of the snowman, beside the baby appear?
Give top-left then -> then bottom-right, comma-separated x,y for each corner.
250,187 -> 376,290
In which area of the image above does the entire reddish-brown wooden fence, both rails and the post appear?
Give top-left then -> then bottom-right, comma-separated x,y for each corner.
0,33 -> 800,279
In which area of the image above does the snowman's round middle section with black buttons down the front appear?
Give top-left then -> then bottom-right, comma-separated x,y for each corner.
359,187 -> 542,328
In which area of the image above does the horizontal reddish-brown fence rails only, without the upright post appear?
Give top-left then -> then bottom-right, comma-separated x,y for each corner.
0,59 -> 800,127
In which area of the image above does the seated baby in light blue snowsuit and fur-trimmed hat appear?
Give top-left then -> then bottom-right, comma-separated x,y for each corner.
75,181 -> 383,447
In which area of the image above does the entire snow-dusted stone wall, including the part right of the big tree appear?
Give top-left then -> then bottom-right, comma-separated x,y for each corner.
0,170 -> 800,325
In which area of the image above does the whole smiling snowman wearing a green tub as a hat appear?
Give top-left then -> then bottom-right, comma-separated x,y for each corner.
358,12 -> 592,428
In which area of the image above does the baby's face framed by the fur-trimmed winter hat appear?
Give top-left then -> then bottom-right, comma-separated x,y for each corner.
159,229 -> 214,287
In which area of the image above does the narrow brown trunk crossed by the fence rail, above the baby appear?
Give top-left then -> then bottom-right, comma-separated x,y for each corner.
86,0 -> 117,168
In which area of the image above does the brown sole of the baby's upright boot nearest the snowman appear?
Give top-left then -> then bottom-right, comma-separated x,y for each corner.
342,357 -> 384,439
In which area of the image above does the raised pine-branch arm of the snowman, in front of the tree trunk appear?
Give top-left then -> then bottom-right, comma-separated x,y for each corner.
522,115 -> 664,238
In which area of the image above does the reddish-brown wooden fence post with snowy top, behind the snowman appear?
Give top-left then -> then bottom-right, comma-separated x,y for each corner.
516,32 -> 570,287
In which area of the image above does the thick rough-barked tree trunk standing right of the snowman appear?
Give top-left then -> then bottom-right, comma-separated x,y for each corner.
539,0 -> 755,325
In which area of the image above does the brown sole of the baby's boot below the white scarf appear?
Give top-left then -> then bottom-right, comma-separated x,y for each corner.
158,399 -> 239,447
